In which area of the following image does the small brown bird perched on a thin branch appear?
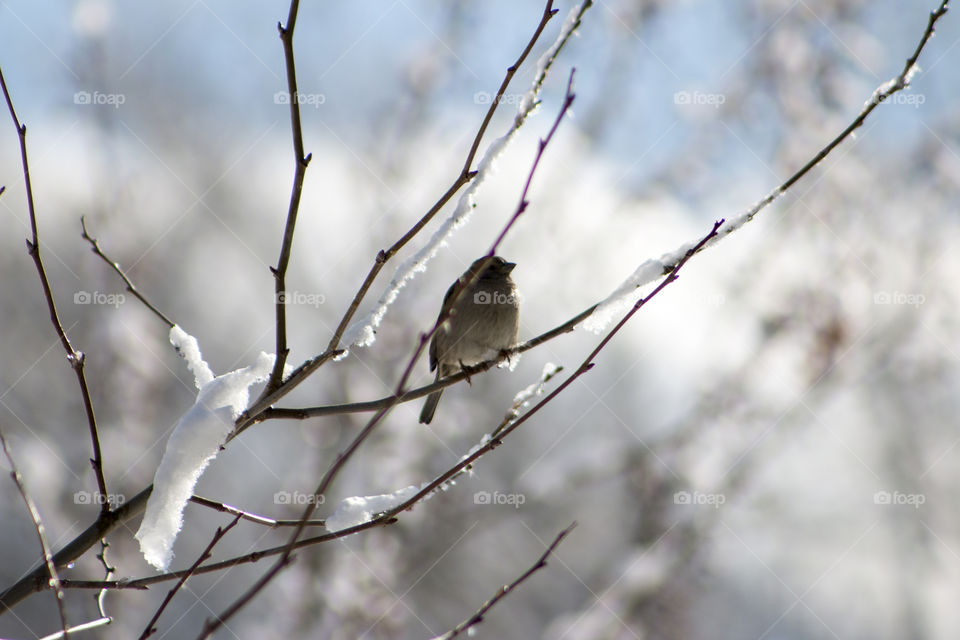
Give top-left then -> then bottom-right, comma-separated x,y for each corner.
420,256 -> 520,424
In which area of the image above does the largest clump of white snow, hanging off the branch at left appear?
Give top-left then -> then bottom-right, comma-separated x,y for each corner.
136,326 -> 282,570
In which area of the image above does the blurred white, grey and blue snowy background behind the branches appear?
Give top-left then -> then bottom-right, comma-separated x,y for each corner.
0,0 -> 960,640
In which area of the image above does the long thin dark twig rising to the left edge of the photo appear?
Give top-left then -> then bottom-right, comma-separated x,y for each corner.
0,68 -> 110,515
